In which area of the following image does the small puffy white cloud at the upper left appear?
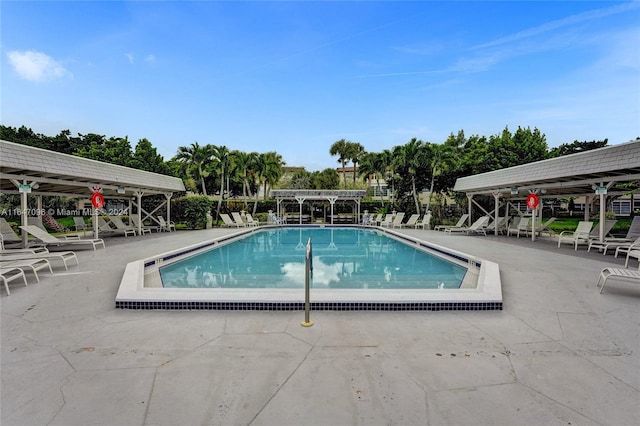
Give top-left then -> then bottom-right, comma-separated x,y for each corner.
7,50 -> 73,82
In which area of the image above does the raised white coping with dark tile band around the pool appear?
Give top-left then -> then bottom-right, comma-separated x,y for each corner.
115,225 -> 502,310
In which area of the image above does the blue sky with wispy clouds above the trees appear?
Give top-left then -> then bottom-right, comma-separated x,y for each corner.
0,1 -> 640,171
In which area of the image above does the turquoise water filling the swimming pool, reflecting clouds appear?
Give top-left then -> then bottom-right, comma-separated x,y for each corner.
159,228 -> 467,289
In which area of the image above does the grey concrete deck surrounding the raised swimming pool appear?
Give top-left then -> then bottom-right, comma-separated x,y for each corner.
0,229 -> 640,425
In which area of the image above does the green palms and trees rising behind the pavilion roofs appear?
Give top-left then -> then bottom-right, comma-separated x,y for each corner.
0,125 -> 608,216
